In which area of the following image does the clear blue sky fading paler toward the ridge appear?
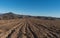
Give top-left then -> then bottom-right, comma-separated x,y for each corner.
0,0 -> 60,17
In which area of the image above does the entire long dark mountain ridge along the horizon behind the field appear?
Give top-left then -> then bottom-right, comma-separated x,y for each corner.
0,12 -> 60,20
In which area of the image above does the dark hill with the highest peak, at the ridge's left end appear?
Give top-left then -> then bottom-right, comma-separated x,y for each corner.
0,12 -> 22,20
